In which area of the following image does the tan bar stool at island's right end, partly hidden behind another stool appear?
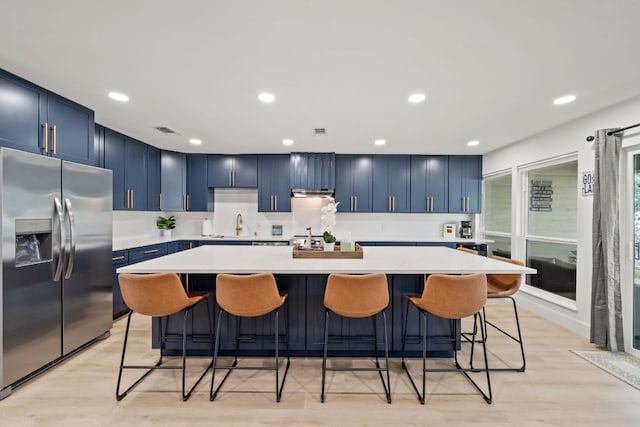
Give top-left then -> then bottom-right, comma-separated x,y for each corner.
483,256 -> 526,372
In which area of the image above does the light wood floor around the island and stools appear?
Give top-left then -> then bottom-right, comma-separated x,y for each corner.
0,301 -> 640,427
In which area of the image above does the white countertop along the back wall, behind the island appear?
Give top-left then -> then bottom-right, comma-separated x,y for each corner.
113,234 -> 493,251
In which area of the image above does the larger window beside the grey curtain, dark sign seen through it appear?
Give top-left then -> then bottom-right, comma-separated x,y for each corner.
523,160 -> 578,301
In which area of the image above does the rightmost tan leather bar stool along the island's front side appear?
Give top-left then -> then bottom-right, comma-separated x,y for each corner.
402,273 -> 493,405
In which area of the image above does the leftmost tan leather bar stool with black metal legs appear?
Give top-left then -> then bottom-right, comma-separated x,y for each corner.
116,273 -> 213,401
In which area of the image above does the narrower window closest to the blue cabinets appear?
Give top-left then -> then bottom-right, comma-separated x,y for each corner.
483,172 -> 511,258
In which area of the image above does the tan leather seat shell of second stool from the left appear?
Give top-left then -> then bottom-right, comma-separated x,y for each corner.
216,273 -> 283,317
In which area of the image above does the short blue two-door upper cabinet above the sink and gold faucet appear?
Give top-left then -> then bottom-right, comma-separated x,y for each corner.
207,154 -> 258,188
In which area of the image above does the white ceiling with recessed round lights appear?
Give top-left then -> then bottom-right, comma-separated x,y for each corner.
0,0 -> 640,154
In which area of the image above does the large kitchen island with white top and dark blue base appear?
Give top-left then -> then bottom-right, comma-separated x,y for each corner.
118,246 -> 536,356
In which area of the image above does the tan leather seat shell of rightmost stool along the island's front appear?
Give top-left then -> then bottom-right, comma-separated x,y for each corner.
416,273 -> 487,319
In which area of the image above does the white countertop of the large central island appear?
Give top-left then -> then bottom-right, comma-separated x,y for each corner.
117,245 -> 536,274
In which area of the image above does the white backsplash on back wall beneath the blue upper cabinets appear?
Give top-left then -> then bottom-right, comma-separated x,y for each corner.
113,189 -> 479,240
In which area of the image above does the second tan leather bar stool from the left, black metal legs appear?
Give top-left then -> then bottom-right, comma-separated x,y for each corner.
209,273 -> 290,402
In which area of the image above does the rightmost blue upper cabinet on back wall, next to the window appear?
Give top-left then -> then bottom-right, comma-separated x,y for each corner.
449,156 -> 482,213
